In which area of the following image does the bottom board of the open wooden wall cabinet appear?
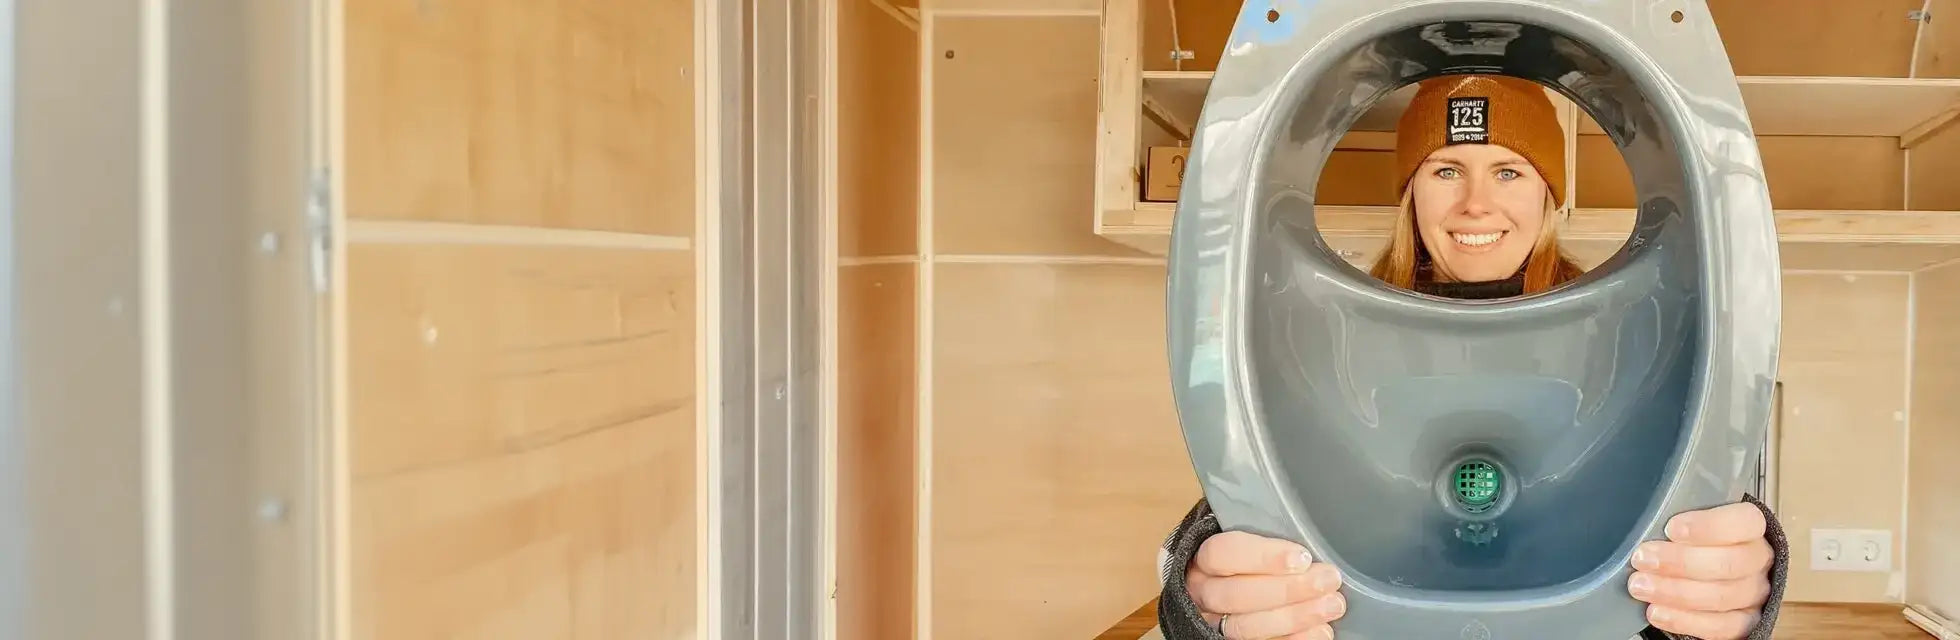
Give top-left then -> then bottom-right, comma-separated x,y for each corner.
1098,202 -> 1960,270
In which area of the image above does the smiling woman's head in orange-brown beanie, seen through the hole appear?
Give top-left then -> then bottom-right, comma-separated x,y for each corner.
1370,76 -> 1582,296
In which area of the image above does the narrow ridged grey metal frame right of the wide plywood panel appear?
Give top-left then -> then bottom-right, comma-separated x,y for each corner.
696,0 -> 835,640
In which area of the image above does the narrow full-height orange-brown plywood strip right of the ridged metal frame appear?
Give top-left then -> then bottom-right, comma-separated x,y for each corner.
835,0 -> 921,638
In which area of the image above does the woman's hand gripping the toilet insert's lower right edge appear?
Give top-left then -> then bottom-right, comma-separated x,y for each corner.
1627,503 -> 1776,640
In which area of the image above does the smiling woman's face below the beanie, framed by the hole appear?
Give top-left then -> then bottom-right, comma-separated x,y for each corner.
1409,145 -> 1546,282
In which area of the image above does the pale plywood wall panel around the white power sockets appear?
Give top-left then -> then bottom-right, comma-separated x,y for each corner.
1778,274 -> 1909,603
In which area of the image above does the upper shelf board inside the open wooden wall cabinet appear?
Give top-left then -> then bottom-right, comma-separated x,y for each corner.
1143,70 -> 1960,149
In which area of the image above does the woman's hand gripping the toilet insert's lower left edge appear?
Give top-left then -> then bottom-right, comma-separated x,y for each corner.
1184,530 -> 1347,640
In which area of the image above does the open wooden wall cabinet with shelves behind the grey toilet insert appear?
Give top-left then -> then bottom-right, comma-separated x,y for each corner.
1096,0 -> 1960,272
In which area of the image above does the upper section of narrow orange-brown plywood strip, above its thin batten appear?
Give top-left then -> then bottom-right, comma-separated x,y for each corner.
837,0 -> 921,256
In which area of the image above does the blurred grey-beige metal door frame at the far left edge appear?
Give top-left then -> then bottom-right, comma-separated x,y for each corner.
0,0 -> 323,640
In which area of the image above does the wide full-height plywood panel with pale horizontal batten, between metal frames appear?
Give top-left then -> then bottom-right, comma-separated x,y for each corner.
341,0 -> 700,640
